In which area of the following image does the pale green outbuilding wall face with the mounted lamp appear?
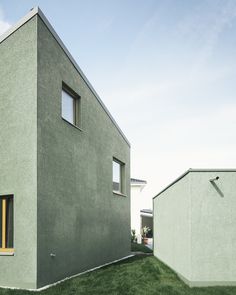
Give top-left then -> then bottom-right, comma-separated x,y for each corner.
190,172 -> 236,286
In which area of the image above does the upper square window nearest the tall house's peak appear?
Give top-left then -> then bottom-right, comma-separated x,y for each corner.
61,86 -> 81,127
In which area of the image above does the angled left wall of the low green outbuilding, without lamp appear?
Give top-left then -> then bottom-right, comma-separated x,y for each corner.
153,174 -> 191,280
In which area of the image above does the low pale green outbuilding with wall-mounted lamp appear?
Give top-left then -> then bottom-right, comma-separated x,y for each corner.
153,169 -> 236,287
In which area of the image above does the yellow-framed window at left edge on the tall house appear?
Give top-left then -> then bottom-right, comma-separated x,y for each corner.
0,195 -> 14,252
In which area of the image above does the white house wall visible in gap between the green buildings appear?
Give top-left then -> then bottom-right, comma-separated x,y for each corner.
130,178 -> 147,243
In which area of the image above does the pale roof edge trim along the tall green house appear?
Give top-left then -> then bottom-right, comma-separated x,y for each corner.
0,6 -> 130,146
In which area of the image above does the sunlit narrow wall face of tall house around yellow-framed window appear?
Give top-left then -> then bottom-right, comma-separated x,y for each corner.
0,18 -> 37,288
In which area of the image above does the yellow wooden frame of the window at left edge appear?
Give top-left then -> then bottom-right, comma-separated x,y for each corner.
0,195 -> 14,253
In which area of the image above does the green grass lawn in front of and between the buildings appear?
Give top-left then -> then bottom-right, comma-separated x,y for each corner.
0,255 -> 236,295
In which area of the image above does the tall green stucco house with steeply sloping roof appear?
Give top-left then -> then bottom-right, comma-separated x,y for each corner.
0,8 -> 130,289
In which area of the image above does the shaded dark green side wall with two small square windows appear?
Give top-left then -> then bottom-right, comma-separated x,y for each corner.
37,16 -> 130,287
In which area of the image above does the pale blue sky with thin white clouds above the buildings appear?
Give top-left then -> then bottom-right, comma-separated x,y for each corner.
0,0 -> 236,207
